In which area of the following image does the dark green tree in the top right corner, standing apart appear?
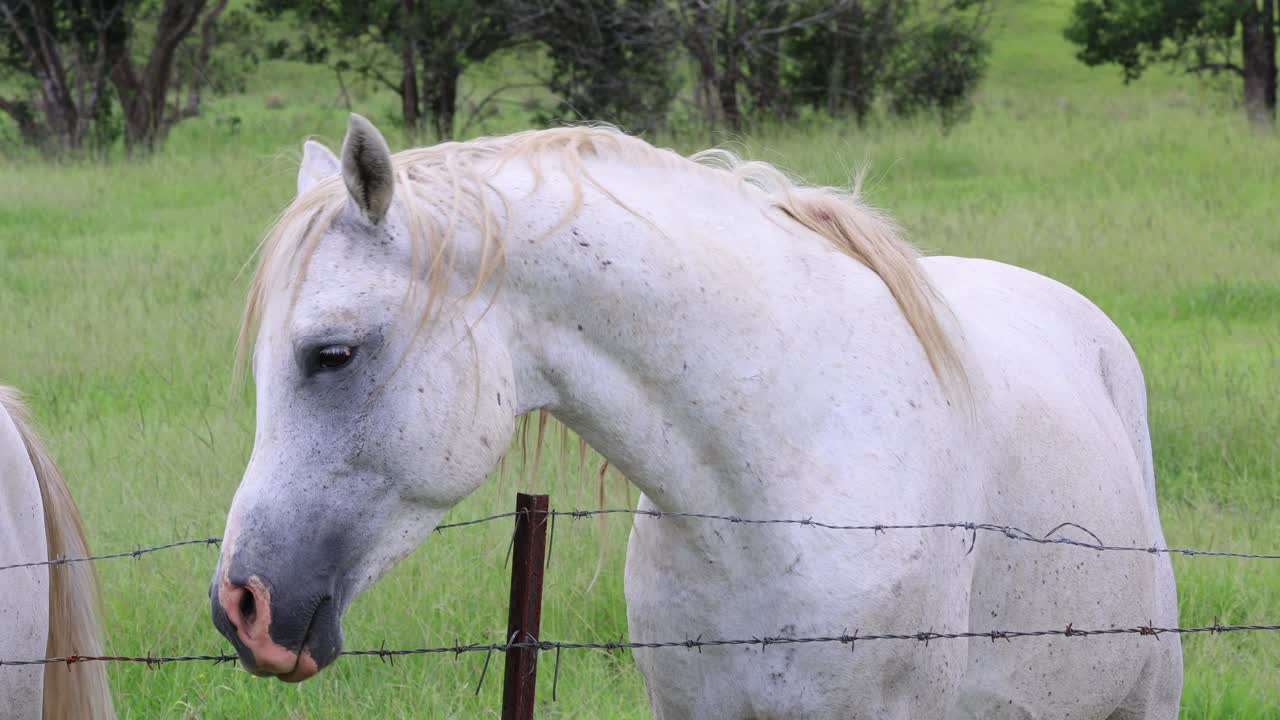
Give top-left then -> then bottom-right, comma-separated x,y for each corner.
1065,0 -> 1277,126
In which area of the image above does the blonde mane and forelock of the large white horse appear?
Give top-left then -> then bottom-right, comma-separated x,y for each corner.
237,127 -> 966,387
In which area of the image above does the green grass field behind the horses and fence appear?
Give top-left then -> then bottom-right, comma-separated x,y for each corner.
0,0 -> 1280,719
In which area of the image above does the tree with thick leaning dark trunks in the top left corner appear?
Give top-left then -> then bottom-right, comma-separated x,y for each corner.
0,0 -> 241,154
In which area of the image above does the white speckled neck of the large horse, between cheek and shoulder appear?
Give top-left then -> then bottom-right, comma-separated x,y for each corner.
483,161 -> 886,512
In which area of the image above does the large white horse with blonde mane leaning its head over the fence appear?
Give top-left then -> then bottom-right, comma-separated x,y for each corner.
211,115 -> 1181,719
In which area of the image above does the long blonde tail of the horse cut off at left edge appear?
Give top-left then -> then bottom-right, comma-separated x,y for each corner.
0,386 -> 115,720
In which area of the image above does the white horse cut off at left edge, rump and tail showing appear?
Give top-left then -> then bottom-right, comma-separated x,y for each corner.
0,386 -> 115,720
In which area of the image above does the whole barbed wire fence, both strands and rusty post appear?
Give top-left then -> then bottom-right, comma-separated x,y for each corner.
0,493 -> 1280,717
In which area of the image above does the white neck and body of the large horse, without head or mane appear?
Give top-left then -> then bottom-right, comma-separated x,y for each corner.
495,164 -> 1180,719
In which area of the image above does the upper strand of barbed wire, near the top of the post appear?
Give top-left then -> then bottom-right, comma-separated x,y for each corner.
0,507 -> 1280,571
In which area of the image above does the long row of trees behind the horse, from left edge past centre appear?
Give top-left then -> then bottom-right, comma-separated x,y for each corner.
0,0 -> 993,152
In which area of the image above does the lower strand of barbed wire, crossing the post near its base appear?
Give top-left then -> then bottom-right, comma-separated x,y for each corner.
0,623 -> 1280,667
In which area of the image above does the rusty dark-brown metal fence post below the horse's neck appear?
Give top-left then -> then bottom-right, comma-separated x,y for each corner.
502,493 -> 550,720
